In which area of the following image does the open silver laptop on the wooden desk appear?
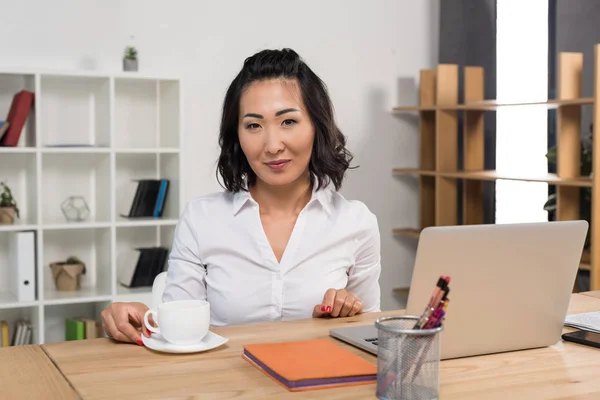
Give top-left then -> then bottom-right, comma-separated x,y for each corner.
330,220 -> 588,359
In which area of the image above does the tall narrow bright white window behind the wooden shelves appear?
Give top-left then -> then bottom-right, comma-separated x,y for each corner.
496,0 -> 548,224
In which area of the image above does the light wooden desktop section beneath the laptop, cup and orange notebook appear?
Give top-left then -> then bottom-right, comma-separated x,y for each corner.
39,294 -> 600,399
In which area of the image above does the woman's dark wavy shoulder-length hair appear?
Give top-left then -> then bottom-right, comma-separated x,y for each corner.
217,49 -> 353,192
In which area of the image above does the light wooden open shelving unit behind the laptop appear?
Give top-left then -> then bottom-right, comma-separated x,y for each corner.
392,44 -> 600,290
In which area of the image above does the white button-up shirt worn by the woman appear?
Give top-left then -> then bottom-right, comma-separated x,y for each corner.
163,183 -> 381,326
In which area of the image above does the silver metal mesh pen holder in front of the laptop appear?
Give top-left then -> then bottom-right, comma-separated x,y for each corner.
375,316 -> 443,400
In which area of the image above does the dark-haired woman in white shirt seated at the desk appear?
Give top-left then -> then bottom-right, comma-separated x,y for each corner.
102,49 -> 381,344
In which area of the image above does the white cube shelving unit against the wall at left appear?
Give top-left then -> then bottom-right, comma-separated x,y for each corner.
0,70 -> 184,344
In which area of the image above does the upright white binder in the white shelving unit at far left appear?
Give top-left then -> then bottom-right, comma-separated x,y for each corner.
8,231 -> 36,301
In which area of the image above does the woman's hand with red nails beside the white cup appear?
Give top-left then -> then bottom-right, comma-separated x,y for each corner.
100,302 -> 152,346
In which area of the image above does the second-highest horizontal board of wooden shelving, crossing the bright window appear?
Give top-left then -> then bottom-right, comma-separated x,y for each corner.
393,168 -> 592,187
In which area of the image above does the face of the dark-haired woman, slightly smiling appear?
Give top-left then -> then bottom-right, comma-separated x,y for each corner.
238,79 -> 315,191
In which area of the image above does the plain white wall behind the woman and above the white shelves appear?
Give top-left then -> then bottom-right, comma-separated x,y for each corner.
0,0 -> 438,309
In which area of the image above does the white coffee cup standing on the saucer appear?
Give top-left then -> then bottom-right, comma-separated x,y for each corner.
144,300 -> 210,346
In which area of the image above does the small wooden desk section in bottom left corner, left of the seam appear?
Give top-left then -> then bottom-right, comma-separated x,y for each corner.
0,345 -> 79,400
